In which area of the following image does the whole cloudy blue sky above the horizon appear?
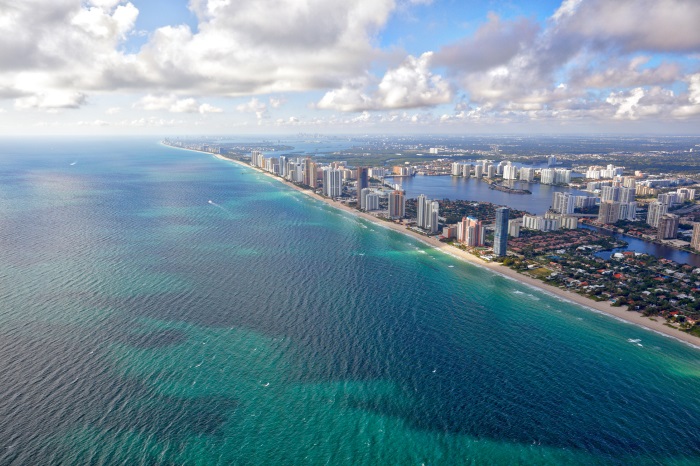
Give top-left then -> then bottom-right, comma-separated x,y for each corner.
0,0 -> 700,135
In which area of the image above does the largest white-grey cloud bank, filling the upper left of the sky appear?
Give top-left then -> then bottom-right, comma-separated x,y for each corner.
0,0 -> 396,102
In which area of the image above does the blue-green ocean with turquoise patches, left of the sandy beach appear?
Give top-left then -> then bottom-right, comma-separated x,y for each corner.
0,139 -> 700,465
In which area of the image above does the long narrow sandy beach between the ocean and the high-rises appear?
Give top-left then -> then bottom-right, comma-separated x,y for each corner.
179,146 -> 700,349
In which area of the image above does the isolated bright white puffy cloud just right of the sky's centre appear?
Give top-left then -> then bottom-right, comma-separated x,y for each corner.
317,52 -> 453,111
